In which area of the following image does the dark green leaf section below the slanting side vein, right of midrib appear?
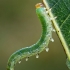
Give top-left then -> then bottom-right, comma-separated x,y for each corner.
60,15 -> 70,50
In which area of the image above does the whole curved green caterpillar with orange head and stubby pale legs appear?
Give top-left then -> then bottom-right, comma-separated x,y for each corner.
7,3 -> 54,70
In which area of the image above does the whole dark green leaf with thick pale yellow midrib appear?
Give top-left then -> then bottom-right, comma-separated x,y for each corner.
43,0 -> 70,69
